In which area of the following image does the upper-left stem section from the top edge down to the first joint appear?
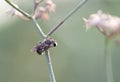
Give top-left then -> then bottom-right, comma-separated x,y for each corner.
5,0 -> 32,19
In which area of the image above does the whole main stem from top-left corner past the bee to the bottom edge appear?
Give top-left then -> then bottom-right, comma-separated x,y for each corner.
5,0 -> 56,82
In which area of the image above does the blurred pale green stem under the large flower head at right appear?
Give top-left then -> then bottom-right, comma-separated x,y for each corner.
105,37 -> 114,82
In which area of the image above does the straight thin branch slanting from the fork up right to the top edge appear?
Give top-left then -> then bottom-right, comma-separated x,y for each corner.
47,0 -> 88,36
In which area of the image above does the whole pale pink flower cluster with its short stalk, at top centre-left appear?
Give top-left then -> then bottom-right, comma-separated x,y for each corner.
33,0 -> 56,20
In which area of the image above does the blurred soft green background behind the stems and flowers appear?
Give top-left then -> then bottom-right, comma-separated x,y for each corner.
0,0 -> 120,82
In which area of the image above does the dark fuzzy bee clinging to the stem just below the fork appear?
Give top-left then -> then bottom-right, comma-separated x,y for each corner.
33,38 -> 57,55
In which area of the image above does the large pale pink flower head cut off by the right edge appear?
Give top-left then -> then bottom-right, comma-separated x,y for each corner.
83,10 -> 120,37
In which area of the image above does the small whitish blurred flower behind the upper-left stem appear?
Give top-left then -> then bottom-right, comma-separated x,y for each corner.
7,8 -> 30,21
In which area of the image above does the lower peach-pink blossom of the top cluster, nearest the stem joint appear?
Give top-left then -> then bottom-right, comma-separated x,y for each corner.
33,7 -> 49,20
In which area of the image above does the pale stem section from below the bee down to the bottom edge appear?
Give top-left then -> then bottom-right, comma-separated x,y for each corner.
45,51 -> 56,82
